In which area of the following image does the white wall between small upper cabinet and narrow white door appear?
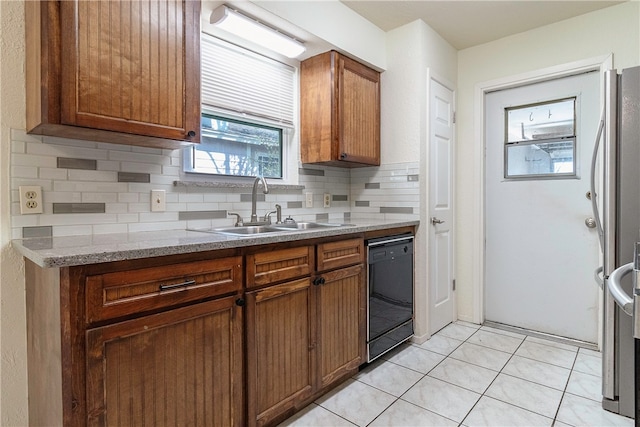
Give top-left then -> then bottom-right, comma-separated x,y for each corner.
381,20 -> 457,341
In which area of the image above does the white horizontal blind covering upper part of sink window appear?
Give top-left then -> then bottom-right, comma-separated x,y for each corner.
201,33 -> 295,126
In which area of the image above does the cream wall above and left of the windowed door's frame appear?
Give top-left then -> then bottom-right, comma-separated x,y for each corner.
456,1 -> 640,321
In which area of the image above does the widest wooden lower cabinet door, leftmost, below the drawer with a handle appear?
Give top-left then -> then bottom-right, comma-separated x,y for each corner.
86,297 -> 244,426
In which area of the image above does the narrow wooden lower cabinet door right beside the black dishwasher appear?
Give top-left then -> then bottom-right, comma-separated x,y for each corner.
314,264 -> 367,388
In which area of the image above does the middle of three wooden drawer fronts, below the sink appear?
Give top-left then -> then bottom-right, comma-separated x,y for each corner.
247,246 -> 314,287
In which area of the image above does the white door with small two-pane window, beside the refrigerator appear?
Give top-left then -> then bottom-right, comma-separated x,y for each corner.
484,72 -> 600,343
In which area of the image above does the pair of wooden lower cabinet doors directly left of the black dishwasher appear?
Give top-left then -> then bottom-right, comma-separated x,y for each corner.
246,252 -> 366,426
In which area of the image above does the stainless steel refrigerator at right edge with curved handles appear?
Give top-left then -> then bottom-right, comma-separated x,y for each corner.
592,67 -> 640,418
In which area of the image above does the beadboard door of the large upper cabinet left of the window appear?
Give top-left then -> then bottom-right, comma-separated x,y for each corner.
61,0 -> 200,142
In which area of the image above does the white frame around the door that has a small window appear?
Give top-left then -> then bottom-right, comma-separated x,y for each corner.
471,54 -> 613,324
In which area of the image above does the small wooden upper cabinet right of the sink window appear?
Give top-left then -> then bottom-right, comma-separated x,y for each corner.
300,51 -> 380,167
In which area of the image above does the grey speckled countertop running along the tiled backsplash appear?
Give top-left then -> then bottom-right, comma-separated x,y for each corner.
11,221 -> 420,267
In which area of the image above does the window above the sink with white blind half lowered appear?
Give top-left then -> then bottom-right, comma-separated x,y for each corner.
183,33 -> 298,184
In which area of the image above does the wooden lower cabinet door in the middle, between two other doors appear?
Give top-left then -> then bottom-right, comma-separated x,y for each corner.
246,278 -> 315,426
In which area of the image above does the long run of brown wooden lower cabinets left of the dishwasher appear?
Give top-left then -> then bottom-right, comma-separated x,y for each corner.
25,236 -> 366,427
